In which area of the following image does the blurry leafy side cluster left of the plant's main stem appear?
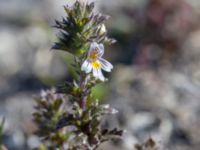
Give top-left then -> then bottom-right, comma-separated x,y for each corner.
33,90 -> 67,149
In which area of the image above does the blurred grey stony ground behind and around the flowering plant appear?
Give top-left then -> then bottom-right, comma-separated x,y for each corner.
0,0 -> 200,150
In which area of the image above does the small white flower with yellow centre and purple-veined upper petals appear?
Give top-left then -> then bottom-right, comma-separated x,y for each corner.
81,42 -> 113,81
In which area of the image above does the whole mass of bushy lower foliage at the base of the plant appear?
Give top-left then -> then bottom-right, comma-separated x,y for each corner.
33,90 -> 122,150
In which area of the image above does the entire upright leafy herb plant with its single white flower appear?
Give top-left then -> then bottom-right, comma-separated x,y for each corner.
33,0 -> 122,150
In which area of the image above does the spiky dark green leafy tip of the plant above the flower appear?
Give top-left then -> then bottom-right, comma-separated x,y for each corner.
52,1 -> 115,54
